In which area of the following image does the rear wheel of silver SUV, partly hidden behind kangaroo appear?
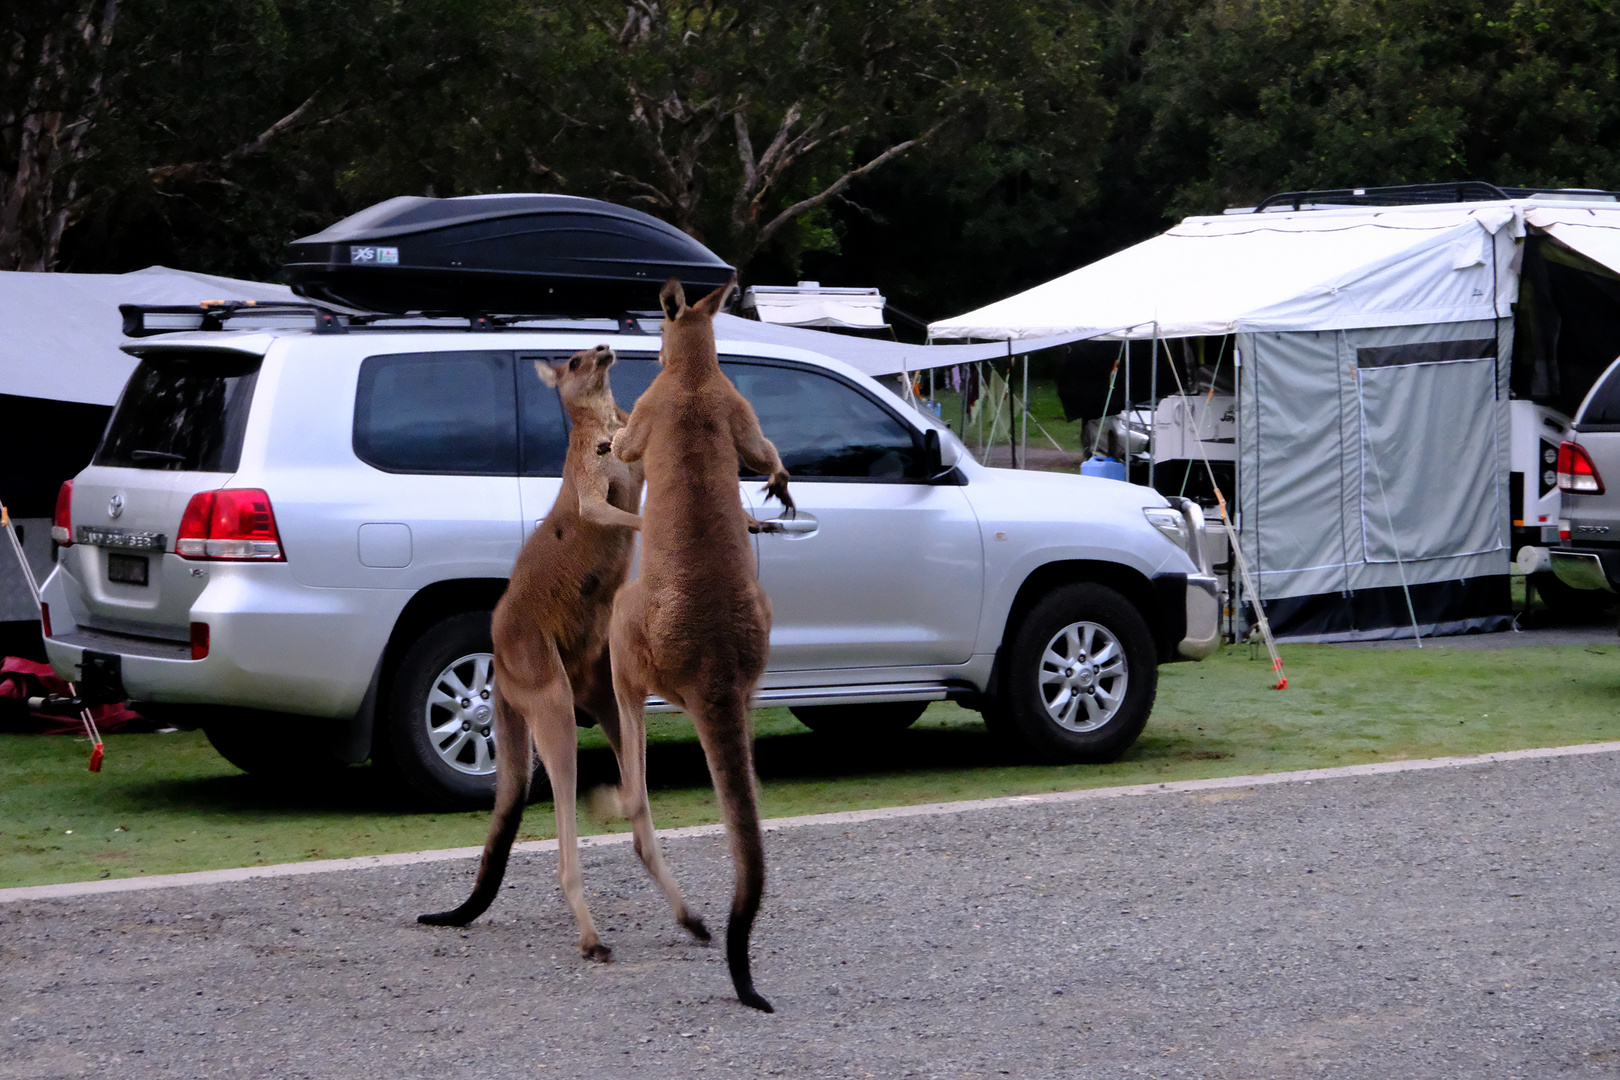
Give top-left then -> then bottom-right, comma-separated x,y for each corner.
373,612 -> 496,810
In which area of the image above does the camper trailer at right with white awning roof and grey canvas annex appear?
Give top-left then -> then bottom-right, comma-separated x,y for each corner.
930,183 -> 1620,641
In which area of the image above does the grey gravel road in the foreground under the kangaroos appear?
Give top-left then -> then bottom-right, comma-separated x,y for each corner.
0,753 -> 1620,1080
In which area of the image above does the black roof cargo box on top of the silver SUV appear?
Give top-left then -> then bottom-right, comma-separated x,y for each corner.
287,194 -> 735,317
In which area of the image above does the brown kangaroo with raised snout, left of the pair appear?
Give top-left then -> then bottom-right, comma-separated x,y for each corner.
418,345 -> 710,960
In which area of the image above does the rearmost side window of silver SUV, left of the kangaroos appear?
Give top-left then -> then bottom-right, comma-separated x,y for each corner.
355,351 -> 517,476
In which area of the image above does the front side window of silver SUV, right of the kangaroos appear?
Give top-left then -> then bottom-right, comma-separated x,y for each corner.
721,358 -> 925,481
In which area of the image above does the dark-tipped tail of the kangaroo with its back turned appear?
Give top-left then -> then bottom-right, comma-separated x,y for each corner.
700,698 -> 774,1012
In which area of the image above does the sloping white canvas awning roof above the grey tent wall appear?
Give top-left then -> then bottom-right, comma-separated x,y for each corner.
928,202 -> 1522,340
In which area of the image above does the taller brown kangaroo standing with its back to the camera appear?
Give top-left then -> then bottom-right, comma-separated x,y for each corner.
609,279 -> 794,1012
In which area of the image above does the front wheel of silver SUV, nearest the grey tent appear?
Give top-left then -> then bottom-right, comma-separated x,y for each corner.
987,581 -> 1158,764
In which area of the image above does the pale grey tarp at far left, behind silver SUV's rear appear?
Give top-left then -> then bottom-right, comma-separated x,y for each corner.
0,266 -> 296,405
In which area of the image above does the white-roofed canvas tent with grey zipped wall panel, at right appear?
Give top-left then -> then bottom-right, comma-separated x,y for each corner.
930,199 -> 1620,640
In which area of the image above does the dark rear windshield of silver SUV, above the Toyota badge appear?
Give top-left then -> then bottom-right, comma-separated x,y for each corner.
94,350 -> 261,473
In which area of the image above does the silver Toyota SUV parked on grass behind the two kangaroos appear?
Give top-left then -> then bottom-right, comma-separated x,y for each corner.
44,307 -> 1220,803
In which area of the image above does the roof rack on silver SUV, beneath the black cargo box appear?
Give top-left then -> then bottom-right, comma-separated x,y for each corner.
118,300 -> 663,337
